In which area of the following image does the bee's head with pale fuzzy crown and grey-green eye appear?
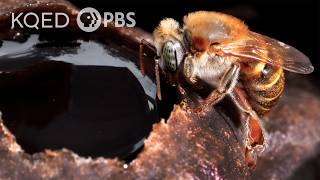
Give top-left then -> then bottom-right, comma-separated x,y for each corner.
153,18 -> 186,73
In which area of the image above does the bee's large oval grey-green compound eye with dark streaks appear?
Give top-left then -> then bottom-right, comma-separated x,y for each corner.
160,41 -> 184,72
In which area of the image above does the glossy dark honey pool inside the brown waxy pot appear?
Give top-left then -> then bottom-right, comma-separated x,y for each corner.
0,35 -> 159,160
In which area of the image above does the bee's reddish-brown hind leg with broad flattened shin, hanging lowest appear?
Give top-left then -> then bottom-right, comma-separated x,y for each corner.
230,87 -> 267,167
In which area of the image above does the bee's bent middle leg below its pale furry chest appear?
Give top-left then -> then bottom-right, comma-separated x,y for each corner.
201,64 -> 240,108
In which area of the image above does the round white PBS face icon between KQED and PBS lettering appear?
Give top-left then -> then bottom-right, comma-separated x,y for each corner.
77,7 -> 101,32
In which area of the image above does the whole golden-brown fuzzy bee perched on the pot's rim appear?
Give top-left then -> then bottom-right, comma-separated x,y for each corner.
140,11 -> 314,167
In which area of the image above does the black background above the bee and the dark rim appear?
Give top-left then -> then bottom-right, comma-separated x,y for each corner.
71,0 -> 320,74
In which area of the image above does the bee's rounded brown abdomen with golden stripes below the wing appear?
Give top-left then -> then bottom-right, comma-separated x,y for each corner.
242,63 -> 285,116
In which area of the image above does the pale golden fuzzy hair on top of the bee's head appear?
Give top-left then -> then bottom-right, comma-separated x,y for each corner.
153,18 -> 182,54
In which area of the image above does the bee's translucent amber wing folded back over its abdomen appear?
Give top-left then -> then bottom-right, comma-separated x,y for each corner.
219,32 -> 314,74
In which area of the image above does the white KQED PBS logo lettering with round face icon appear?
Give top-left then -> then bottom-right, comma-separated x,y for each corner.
11,7 -> 136,32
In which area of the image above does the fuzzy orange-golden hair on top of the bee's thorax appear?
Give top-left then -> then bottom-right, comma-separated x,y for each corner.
183,11 -> 248,43
